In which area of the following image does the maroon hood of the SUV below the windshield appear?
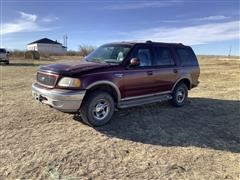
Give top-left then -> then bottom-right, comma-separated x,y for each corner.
40,60 -> 111,75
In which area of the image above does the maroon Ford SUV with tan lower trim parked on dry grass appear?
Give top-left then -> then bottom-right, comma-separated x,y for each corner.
32,41 -> 200,126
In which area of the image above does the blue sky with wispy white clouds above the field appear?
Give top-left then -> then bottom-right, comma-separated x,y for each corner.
0,0 -> 240,55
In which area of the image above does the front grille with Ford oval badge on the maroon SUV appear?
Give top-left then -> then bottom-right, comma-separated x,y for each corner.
37,72 -> 58,87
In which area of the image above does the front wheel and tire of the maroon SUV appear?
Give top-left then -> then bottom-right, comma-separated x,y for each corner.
80,91 -> 115,127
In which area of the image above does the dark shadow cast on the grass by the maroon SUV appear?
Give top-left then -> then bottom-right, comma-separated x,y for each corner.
75,98 -> 240,153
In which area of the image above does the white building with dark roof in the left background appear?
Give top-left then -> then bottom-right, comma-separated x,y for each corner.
27,38 -> 67,54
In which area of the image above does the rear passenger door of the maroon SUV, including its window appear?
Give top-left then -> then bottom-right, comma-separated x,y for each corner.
153,45 -> 179,92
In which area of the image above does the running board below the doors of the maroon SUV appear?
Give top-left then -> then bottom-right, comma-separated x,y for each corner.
118,94 -> 172,108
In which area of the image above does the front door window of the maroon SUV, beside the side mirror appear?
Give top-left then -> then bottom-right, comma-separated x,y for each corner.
134,47 -> 152,66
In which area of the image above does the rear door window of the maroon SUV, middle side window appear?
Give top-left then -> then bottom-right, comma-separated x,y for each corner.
153,47 -> 174,66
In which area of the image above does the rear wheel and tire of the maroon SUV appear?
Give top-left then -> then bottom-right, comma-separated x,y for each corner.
170,83 -> 188,107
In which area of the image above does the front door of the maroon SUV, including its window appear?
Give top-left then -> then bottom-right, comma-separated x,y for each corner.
124,44 -> 156,98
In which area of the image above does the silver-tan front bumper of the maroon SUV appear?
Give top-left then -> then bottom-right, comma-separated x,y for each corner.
32,83 -> 86,113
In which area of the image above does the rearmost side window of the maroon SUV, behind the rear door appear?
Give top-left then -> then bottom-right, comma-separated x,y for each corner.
177,48 -> 198,66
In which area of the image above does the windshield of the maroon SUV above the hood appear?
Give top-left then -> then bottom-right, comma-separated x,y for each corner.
85,44 -> 132,64
